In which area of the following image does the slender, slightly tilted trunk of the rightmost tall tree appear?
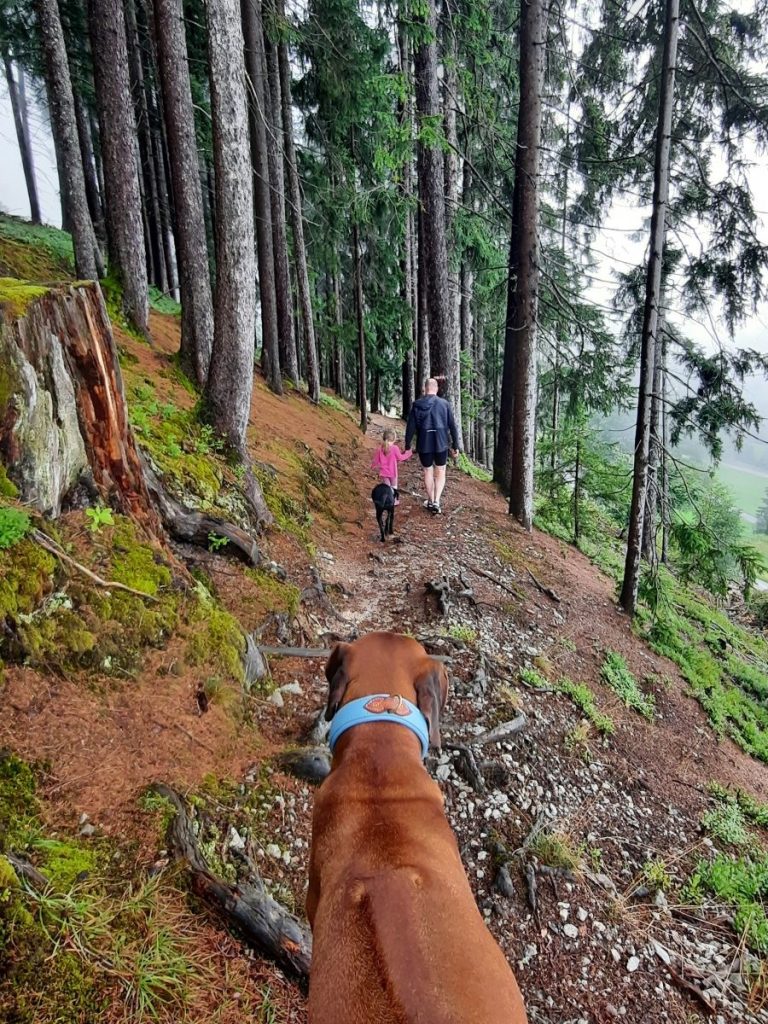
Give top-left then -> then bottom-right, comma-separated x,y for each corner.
620,0 -> 680,615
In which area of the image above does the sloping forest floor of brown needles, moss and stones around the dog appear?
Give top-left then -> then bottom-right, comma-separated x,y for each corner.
0,220 -> 768,1024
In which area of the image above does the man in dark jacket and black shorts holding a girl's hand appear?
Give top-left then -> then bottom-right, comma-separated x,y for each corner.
403,377 -> 459,515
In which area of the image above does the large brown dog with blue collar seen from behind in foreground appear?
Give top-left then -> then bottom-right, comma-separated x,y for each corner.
307,633 -> 527,1024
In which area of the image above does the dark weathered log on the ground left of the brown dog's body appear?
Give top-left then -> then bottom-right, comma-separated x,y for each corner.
154,783 -> 312,981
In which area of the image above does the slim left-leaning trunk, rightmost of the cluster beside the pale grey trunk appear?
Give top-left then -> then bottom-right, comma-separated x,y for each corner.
275,0 -> 319,403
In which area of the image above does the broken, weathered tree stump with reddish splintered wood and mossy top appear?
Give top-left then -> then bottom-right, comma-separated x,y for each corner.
0,284 -> 162,537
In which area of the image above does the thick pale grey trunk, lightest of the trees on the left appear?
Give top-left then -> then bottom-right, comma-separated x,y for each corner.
206,0 -> 256,458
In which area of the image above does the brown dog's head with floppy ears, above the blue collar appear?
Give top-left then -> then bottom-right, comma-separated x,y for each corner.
326,633 -> 449,749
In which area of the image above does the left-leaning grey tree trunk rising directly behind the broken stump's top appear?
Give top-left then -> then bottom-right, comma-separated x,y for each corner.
37,0 -> 100,281
